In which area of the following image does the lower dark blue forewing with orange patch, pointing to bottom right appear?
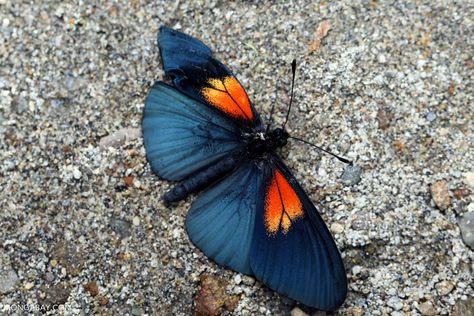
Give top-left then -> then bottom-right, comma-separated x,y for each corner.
250,156 -> 347,311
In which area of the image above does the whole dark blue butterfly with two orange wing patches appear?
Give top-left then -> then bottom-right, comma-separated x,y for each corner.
142,26 -> 347,311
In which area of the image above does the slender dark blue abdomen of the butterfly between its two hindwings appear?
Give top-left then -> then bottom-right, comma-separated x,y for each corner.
162,152 -> 241,203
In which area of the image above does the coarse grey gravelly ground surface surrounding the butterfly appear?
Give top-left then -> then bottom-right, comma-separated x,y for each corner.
0,0 -> 474,315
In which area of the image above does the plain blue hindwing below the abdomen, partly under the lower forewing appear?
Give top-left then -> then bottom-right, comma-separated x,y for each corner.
186,161 -> 263,274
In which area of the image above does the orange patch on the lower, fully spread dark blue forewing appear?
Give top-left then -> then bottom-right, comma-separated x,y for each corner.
265,170 -> 304,235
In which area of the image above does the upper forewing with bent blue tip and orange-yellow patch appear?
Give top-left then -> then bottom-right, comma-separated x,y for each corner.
158,27 -> 261,128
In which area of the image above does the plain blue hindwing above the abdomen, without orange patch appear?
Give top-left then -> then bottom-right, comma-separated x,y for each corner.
142,82 -> 242,180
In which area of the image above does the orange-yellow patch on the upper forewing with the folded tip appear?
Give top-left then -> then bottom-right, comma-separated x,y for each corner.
201,76 -> 253,120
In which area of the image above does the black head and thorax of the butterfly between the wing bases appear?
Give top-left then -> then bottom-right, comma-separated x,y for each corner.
245,128 -> 290,156
